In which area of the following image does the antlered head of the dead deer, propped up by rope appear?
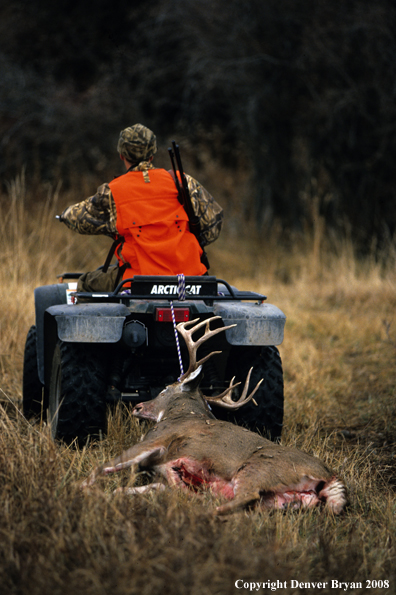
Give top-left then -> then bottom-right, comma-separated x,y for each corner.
132,316 -> 262,422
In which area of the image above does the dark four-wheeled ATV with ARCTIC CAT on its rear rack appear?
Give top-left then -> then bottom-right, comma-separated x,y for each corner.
23,273 -> 286,445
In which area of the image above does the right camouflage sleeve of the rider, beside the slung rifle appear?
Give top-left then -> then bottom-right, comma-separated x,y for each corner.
186,174 -> 223,246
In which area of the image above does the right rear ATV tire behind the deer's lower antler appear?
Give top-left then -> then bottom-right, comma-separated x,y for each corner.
214,346 -> 284,442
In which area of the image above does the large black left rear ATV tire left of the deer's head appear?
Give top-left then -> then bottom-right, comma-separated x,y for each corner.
49,341 -> 107,446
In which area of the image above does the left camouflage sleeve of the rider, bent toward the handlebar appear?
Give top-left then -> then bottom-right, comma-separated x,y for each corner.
61,184 -> 117,236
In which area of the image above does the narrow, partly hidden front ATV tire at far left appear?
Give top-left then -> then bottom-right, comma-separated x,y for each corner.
22,326 -> 43,419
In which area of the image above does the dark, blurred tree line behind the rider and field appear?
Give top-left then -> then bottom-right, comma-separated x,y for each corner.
0,0 -> 396,246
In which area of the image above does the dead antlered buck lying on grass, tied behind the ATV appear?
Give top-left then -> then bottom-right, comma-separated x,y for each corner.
83,317 -> 346,515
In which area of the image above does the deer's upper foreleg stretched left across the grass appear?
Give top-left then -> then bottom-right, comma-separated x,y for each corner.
81,444 -> 167,489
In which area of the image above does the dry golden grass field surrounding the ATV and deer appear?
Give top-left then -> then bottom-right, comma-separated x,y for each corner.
0,176 -> 396,595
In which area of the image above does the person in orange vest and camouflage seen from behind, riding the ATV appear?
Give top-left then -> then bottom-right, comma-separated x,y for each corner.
60,124 -> 223,292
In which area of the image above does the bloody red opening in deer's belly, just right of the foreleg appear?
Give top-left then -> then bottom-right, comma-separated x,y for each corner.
165,458 -> 235,500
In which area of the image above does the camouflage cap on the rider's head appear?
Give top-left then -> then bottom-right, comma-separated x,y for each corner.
117,124 -> 157,163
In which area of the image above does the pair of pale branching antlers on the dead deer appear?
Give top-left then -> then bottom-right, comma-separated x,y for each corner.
177,316 -> 263,409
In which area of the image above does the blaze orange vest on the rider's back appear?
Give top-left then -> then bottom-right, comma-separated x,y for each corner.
109,169 -> 206,279
